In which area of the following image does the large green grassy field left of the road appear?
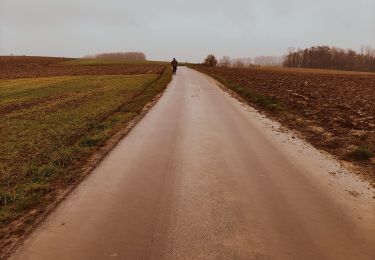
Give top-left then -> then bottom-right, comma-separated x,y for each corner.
0,66 -> 172,228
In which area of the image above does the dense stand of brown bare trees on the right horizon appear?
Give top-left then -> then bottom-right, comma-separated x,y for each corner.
283,46 -> 375,71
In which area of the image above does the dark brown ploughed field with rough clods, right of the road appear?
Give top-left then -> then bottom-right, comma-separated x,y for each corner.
194,66 -> 375,185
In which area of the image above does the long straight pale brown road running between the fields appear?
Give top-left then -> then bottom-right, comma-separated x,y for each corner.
12,68 -> 375,260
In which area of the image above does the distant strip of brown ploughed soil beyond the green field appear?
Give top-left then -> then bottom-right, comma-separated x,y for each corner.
0,56 -> 163,79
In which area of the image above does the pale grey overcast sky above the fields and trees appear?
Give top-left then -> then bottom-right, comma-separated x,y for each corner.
0,0 -> 375,61
